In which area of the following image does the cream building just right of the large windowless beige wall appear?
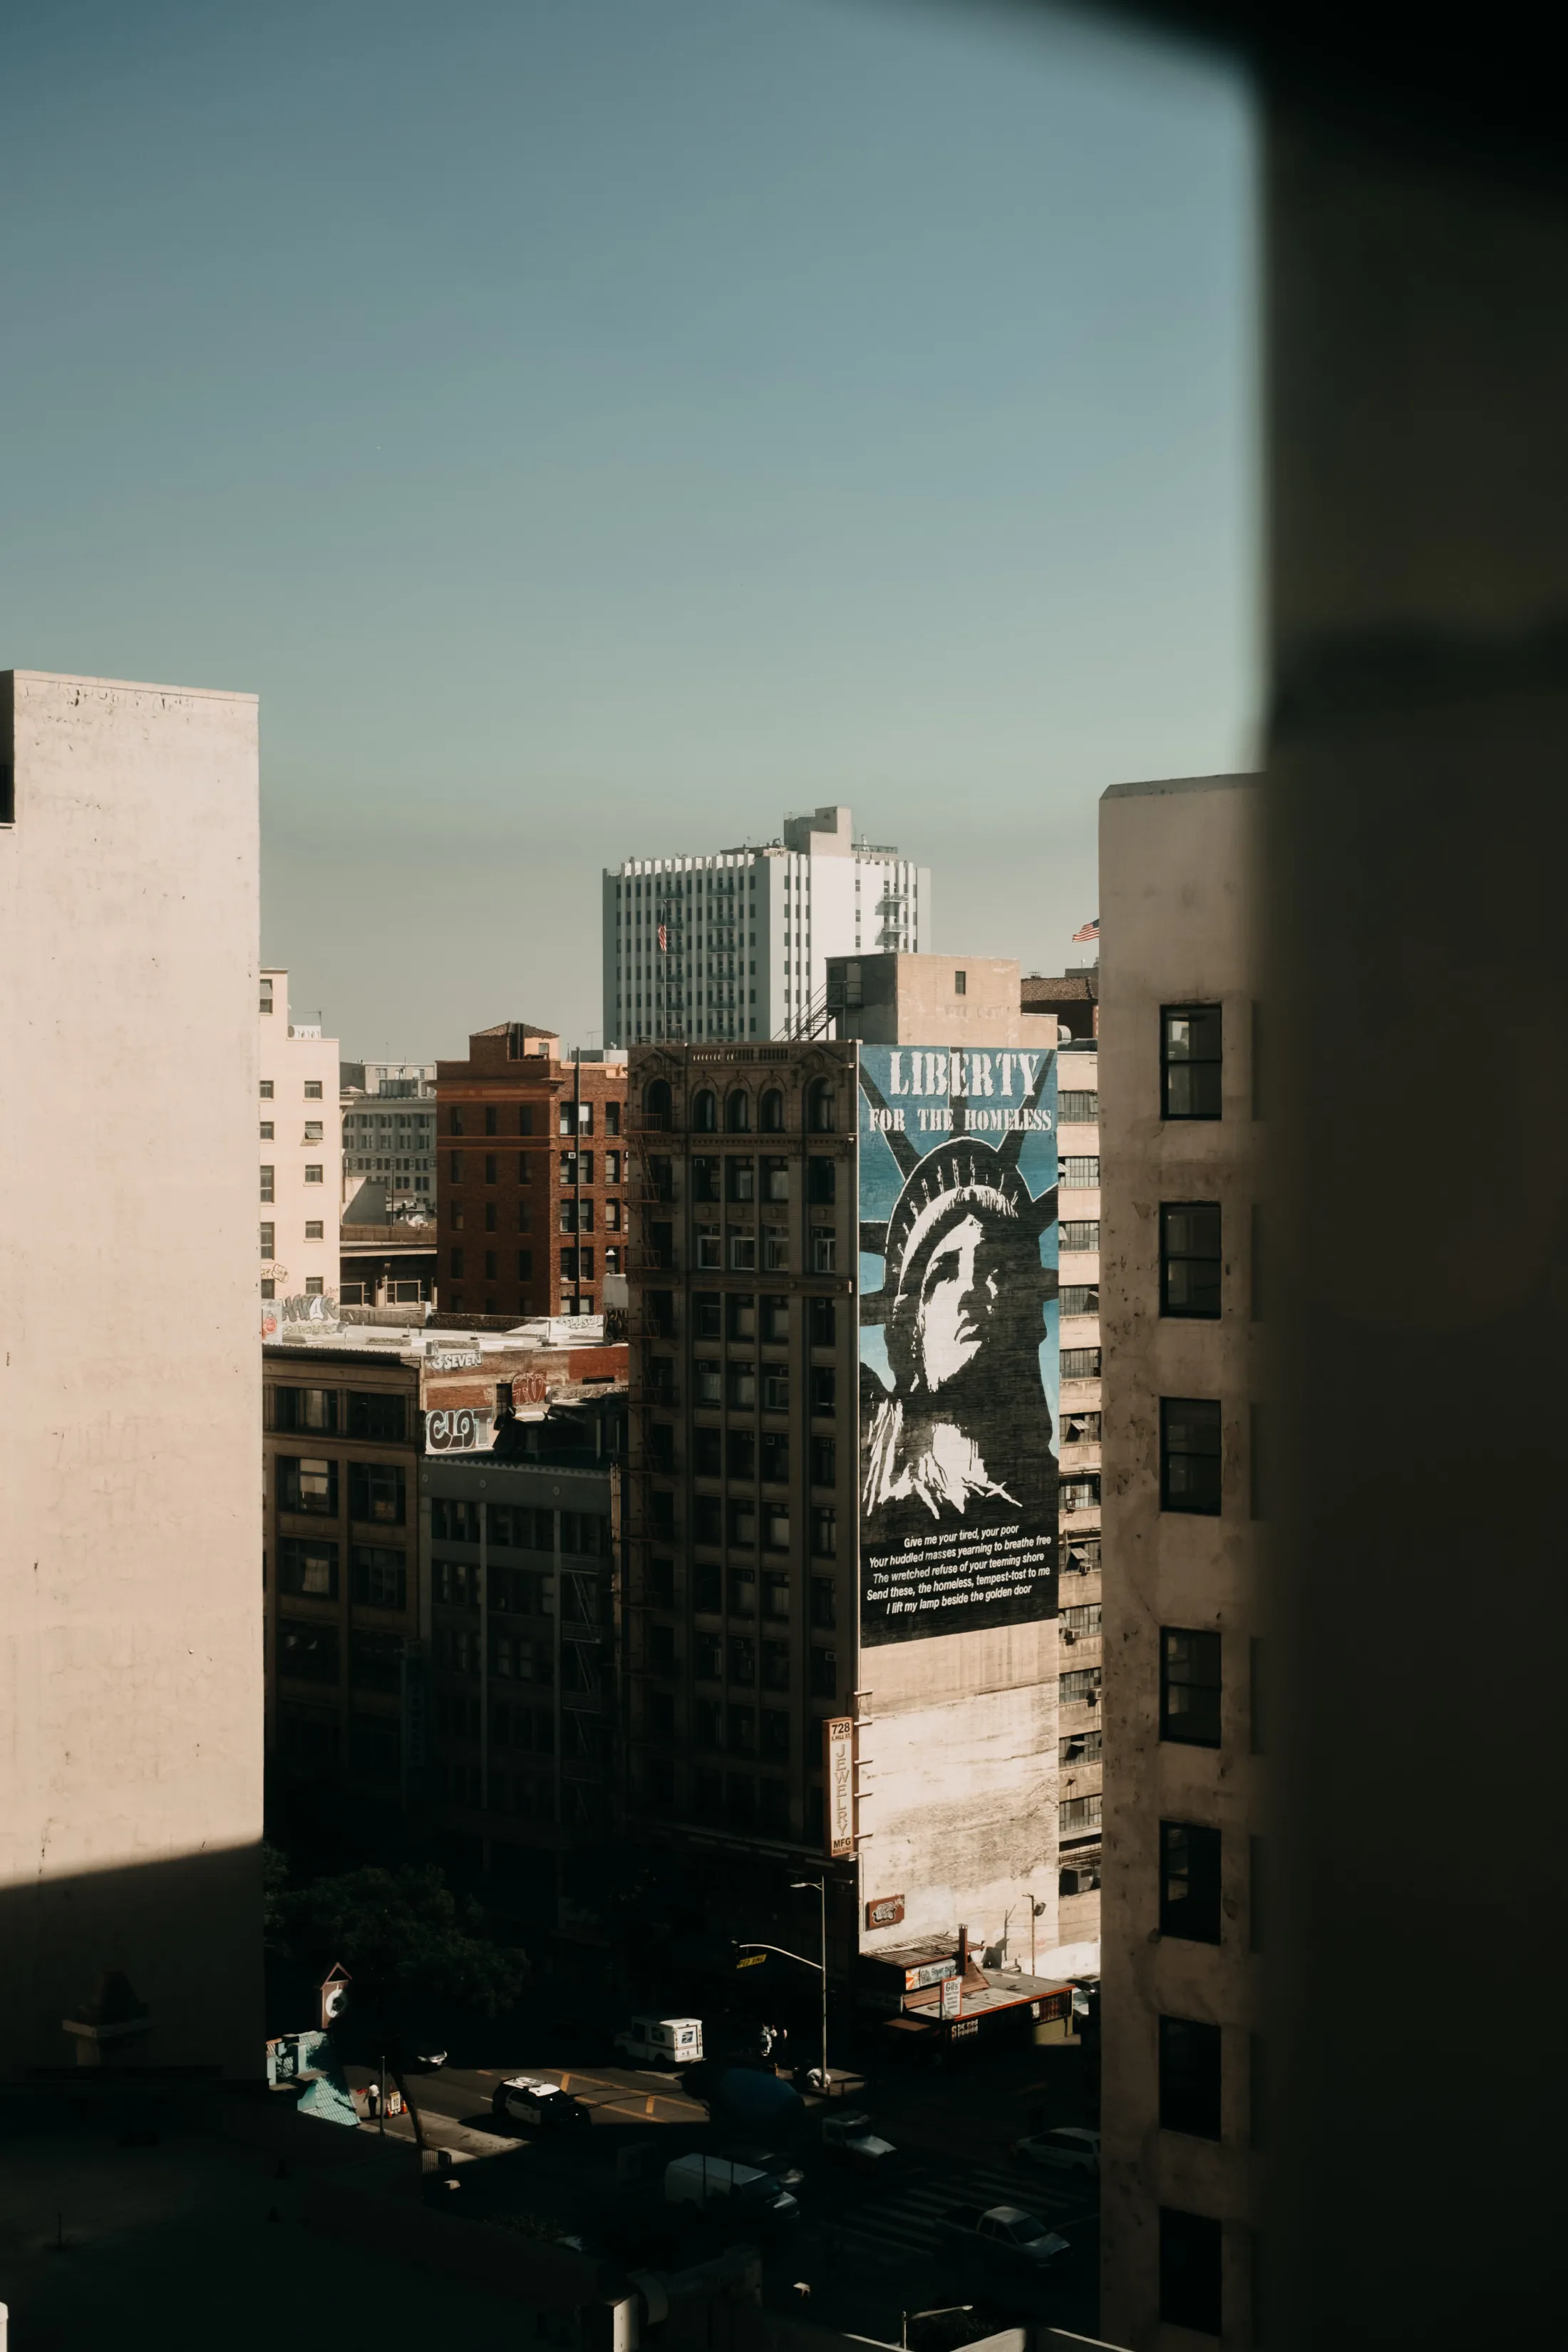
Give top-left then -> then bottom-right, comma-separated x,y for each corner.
257,966 -> 344,1299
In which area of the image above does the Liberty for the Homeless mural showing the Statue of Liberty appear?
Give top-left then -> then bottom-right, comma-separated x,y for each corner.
858,1047 -> 1058,1646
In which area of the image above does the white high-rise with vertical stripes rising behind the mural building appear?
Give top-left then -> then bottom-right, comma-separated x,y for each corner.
604,809 -> 931,1044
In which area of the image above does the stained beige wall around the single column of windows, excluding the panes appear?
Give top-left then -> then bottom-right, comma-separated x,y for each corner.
1098,776 -> 1260,2352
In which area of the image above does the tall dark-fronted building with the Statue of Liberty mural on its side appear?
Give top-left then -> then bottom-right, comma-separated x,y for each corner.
628,978 -> 1081,2032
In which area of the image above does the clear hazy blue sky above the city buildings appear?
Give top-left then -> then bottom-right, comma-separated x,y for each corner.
0,0 -> 1255,1056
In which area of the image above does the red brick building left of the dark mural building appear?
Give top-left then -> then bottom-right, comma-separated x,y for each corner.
435,1021 -> 628,1317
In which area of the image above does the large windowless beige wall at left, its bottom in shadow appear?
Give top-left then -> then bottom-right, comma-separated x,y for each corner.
0,673 -> 261,2077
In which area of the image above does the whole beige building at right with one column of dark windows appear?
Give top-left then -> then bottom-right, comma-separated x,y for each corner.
1100,776 -> 1262,2352
